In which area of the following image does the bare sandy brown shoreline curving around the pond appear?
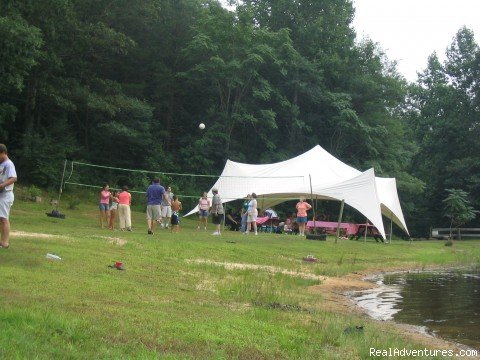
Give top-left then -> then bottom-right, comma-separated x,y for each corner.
312,266 -> 480,359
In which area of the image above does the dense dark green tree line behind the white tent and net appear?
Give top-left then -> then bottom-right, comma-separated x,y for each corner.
0,0 -> 480,234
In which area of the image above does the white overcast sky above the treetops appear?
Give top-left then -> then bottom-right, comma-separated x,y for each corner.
353,0 -> 480,81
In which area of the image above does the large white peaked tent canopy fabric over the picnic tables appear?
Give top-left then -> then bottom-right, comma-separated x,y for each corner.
186,145 -> 408,238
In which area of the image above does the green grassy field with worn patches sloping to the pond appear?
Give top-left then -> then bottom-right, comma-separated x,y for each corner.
0,195 -> 480,359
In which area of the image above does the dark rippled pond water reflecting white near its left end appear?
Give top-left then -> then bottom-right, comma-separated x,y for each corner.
353,271 -> 480,349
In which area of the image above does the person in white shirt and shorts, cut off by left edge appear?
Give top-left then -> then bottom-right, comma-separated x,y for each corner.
0,144 -> 17,249
